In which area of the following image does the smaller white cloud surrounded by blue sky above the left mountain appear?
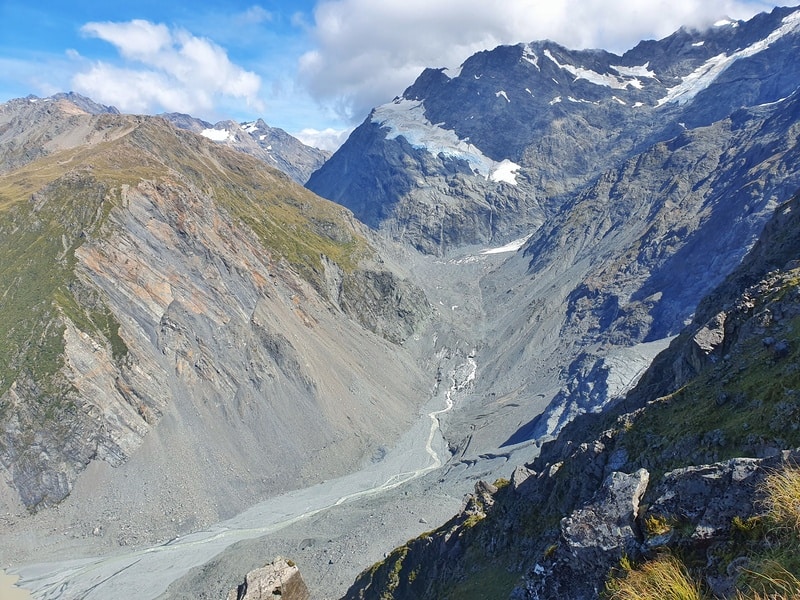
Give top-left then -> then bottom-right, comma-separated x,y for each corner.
72,15 -> 263,114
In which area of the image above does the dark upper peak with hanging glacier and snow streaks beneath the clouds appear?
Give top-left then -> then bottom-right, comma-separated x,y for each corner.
307,9 -> 800,255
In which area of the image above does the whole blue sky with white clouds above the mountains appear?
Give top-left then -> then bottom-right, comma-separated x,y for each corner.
0,0 -> 800,149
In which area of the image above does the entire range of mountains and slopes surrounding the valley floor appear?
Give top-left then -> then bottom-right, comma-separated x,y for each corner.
0,4 -> 800,599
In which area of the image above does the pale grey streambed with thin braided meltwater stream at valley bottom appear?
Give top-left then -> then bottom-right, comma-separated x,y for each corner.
11,366 -> 456,600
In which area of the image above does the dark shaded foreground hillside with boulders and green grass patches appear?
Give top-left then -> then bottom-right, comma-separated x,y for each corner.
346,197 -> 800,600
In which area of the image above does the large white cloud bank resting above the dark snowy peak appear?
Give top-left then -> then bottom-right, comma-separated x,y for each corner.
299,0 -> 792,122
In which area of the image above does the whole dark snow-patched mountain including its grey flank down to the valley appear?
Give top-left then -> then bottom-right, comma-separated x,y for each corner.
300,9 -> 800,474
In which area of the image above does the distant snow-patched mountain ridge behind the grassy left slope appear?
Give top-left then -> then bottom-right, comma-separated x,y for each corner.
161,113 -> 330,185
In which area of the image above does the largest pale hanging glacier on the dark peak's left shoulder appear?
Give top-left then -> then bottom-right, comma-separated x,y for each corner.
372,98 -> 521,185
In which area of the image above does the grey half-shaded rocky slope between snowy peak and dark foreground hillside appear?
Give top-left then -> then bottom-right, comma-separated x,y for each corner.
454,95 -> 800,444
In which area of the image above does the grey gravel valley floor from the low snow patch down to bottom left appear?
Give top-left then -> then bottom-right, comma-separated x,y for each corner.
0,240 -> 624,600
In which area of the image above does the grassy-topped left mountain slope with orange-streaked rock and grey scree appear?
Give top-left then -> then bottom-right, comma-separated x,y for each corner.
0,98 -> 428,510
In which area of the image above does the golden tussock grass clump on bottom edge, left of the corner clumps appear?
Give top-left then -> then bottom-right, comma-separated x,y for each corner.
606,554 -> 707,600
